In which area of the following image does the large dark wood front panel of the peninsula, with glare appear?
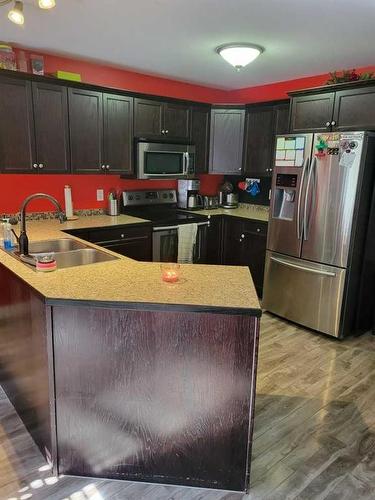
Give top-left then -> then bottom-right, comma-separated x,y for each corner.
53,307 -> 259,491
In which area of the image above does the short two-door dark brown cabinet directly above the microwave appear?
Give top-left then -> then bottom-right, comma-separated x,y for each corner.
134,98 -> 191,141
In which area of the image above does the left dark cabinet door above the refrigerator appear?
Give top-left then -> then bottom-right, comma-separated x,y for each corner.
290,92 -> 335,133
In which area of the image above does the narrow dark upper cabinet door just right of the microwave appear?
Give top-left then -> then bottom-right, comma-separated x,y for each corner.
191,108 -> 210,174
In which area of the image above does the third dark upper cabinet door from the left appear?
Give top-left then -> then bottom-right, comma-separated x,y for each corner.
68,88 -> 104,173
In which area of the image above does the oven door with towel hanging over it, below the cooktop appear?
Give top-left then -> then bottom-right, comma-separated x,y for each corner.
152,222 -> 209,264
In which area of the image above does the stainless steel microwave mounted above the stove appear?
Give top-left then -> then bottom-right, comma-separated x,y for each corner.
137,141 -> 195,179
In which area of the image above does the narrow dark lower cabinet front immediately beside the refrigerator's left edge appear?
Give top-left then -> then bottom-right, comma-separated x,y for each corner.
239,221 -> 267,296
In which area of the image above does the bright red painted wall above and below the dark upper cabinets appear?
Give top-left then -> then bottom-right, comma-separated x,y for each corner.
0,50 -> 375,213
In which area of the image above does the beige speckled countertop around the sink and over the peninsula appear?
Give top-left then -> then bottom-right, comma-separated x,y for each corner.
0,215 -> 260,311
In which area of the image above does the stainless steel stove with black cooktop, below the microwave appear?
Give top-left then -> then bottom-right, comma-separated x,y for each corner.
121,189 -> 209,263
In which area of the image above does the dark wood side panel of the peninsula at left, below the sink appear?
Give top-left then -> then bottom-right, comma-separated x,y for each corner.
0,264 -> 55,460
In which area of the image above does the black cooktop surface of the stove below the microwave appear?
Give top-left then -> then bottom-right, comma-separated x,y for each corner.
124,206 -> 207,226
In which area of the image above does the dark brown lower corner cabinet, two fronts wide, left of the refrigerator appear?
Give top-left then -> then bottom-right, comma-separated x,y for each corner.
223,217 -> 268,297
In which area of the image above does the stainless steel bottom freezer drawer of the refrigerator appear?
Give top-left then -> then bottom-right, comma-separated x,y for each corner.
262,251 -> 346,337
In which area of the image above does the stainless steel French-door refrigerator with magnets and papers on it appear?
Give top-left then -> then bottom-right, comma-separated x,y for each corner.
263,132 -> 375,337
